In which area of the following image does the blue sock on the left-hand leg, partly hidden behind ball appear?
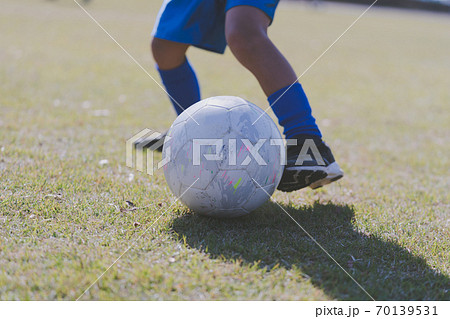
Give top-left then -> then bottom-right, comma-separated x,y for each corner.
157,59 -> 200,115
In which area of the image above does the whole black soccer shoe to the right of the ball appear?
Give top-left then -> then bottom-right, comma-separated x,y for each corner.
278,135 -> 344,192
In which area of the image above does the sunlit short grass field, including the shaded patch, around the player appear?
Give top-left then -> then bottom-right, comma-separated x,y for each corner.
0,0 -> 450,300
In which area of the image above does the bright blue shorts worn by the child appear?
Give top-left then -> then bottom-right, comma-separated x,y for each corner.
152,0 -> 279,53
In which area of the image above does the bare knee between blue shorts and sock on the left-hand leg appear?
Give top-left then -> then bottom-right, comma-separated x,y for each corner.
151,38 -> 189,70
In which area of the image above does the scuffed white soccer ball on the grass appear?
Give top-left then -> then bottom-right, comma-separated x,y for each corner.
163,96 -> 285,217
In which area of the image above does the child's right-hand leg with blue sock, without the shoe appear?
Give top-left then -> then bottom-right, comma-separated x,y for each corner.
225,6 -> 321,138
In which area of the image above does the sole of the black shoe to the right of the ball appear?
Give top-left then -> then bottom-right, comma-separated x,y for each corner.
278,162 -> 344,192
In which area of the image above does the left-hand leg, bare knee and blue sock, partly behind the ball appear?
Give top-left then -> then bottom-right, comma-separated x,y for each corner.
152,38 -> 200,114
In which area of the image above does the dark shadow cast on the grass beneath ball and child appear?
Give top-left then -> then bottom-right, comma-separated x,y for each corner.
173,203 -> 449,300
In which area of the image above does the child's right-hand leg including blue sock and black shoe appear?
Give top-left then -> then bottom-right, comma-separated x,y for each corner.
225,5 -> 344,192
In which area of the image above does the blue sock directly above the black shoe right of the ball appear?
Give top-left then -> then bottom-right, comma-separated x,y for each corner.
267,83 -> 322,138
